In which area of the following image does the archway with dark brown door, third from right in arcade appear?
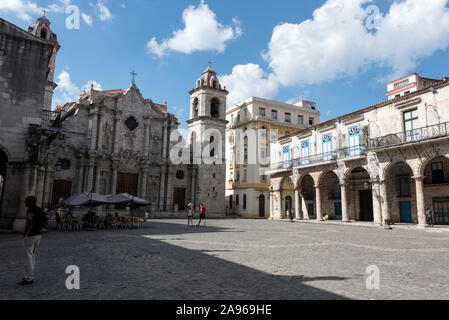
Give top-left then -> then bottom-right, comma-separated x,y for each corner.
347,167 -> 374,222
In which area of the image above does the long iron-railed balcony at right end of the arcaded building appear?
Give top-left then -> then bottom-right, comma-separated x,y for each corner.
369,122 -> 449,150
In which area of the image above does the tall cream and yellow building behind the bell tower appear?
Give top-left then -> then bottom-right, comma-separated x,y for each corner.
226,97 -> 320,218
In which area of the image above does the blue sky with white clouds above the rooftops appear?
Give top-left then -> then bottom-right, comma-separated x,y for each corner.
0,0 -> 449,129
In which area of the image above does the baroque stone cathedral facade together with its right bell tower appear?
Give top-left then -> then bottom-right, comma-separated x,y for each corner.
43,69 -> 227,217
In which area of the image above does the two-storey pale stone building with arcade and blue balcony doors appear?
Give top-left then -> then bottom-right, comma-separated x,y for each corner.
270,78 -> 449,225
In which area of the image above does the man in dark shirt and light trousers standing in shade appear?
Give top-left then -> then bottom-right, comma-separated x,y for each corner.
18,196 -> 48,286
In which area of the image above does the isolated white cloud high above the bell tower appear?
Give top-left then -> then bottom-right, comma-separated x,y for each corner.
147,2 -> 242,57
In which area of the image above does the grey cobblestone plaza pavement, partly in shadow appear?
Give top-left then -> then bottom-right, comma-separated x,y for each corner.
0,219 -> 449,300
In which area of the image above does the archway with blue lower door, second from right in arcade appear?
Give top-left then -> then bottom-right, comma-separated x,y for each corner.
385,162 -> 418,223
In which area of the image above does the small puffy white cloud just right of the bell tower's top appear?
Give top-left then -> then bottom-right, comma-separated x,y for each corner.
220,64 -> 279,106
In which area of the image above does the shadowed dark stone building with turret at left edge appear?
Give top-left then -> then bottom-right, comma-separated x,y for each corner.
0,17 -> 60,228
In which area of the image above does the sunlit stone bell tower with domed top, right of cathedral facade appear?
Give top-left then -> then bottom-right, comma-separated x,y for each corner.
187,67 -> 229,216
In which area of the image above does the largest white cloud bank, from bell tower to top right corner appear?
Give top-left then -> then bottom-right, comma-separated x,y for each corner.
222,0 -> 449,107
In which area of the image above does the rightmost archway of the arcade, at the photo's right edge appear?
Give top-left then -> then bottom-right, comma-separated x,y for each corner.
424,157 -> 449,225
